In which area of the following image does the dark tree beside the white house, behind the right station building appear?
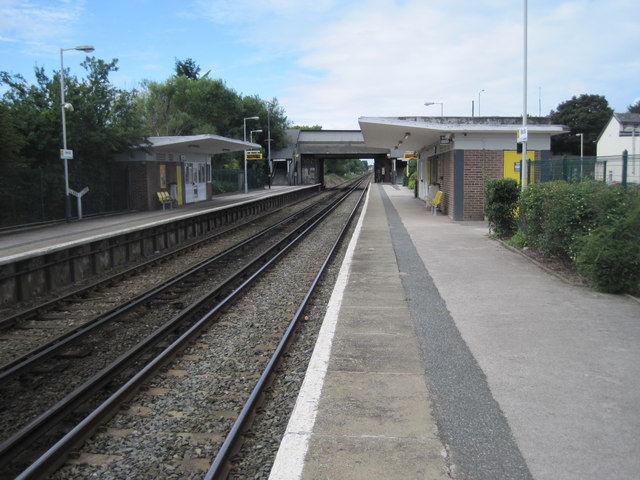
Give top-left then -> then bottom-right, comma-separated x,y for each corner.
551,94 -> 613,156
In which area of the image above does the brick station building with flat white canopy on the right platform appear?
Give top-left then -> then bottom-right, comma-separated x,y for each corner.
358,117 -> 569,220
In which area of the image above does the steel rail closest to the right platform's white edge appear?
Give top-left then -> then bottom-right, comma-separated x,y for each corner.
204,181 -> 369,480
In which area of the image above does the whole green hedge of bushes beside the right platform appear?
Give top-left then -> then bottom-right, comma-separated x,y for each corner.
485,179 -> 640,295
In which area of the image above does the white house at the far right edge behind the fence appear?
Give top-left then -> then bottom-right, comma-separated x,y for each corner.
596,113 -> 640,183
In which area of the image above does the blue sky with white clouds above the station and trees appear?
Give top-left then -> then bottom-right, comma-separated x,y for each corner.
0,0 -> 640,129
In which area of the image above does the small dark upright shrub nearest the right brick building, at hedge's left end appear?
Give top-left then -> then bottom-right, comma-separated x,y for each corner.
484,178 -> 520,237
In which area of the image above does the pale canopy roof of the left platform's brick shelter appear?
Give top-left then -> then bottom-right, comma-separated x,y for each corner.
148,134 -> 261,155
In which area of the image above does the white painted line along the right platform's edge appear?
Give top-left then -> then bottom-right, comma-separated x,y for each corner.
269,188 -> 371,480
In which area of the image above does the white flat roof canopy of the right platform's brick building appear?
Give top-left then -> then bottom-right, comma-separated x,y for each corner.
358,117 -> 569,150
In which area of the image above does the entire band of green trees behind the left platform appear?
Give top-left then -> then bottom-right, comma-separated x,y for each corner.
0,57 -> 288,224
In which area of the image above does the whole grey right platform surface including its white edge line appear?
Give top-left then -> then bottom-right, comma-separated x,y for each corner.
271,184 -> 640,480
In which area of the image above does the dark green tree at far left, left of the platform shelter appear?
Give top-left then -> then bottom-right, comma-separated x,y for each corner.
0,57 -> 144,223
